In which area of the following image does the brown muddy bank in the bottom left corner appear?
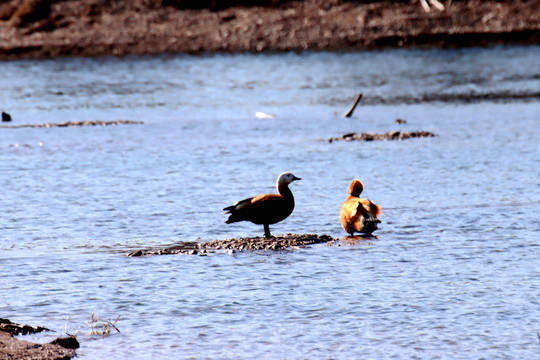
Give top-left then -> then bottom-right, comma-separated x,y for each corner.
0,319 -> 79,360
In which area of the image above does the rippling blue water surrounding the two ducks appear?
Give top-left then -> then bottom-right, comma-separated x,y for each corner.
0,46 -> 540,359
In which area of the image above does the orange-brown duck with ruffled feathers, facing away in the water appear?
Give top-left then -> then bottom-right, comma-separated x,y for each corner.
339,179 -> 381,236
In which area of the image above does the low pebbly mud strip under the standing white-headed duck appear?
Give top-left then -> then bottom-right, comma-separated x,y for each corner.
128,234 -> 335,256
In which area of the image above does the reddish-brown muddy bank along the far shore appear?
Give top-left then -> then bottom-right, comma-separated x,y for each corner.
0,0 -> 540,59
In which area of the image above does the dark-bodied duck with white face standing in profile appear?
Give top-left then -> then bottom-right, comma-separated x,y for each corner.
223,172 -> 302,238
